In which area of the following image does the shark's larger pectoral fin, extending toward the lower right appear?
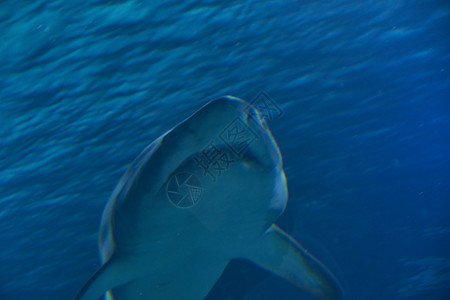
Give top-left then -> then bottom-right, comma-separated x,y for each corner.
247,224 -> 342,300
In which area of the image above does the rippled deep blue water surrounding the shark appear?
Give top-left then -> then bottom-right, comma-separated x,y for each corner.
0,0 -> 450,300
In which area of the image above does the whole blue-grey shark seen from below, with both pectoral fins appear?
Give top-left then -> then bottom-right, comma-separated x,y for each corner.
74,96 -> 342,300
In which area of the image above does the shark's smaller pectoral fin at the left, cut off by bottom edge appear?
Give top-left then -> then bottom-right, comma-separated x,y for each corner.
74,258 -> 133,300
